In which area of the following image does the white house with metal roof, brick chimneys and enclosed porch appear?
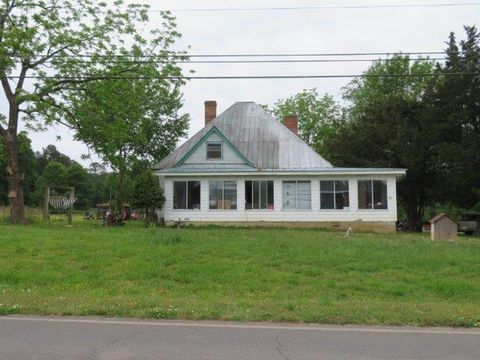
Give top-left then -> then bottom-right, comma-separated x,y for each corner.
154,101 -> 405,232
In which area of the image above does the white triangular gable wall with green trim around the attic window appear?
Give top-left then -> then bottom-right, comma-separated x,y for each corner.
175,127 -> 254,169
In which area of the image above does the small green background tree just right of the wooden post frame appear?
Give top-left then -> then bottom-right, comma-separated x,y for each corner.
65,164 -> 94,209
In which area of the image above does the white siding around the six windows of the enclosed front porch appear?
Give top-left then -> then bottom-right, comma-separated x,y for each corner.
164,175 -> 397,222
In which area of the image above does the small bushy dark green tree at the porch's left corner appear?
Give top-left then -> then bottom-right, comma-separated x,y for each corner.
133,171 -> 165,227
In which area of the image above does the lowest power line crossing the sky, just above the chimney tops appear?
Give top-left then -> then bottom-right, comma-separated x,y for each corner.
7,72 -> 480,81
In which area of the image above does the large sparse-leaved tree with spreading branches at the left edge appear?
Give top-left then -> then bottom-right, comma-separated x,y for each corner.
0,0 -> 178,223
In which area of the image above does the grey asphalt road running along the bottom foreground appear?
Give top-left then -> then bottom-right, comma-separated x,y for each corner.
0,317 -> 480,360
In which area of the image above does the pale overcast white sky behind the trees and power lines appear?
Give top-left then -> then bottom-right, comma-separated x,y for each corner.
4,0 -> 480,166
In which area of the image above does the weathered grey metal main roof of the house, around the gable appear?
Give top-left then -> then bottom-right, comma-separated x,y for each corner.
154,102 -> 333,171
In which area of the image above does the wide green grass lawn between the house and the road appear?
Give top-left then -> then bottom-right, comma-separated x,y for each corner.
0,222 -> 480,327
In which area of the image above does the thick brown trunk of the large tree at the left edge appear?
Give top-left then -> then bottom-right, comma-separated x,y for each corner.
4,109 -> 26,224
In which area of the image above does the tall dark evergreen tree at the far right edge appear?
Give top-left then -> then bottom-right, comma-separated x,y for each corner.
427,26 -> 480,207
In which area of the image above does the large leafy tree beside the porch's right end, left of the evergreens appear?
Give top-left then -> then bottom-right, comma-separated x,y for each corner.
327,55 -> 439,230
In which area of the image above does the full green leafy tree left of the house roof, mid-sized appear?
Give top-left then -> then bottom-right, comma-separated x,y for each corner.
68,59 -> 189,211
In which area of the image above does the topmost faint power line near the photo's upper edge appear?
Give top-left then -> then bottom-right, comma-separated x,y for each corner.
153,2 -> 480,13
